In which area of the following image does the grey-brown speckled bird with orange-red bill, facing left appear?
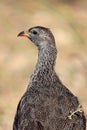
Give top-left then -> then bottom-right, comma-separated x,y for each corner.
13,26 -> 86,130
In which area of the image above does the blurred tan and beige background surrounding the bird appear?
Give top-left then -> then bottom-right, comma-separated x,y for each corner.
0,0 -> 87,130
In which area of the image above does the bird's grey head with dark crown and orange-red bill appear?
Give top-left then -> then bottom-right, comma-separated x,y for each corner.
18,26 -> 55,47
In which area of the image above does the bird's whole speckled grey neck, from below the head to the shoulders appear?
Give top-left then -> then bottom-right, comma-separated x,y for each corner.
29,46 -> 57,87
